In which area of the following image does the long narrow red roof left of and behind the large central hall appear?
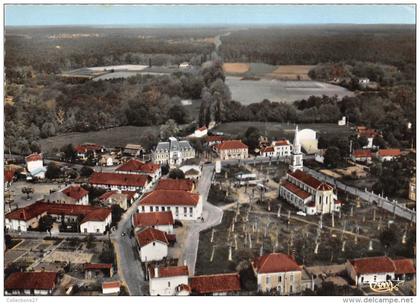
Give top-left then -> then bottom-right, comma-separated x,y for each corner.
89,172 -> 148,187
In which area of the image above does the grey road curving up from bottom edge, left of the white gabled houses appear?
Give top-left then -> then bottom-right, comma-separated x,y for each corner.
111,192 -> 147,296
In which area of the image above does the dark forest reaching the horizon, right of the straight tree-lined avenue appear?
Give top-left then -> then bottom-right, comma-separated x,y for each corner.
220,25 -> 416,67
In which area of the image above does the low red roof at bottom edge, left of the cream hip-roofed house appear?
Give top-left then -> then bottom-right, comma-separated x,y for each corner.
190,273 -> 241,294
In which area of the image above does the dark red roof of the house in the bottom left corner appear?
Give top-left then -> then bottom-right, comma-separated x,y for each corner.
4,272 -> 57,290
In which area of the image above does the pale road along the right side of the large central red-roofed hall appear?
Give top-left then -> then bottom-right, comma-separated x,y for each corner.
184,164 -> 223,275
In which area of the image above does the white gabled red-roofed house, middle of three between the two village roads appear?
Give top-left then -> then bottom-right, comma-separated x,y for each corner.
136,227 -> 169,262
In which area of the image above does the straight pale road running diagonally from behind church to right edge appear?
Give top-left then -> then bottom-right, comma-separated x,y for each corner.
304,167 -> 416,222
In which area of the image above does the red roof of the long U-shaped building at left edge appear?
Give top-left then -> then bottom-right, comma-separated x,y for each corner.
5,201 -> 111,221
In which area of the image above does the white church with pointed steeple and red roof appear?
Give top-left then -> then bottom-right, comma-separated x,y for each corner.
279,126 -> 341,215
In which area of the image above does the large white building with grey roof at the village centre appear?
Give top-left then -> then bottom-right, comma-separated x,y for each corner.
152,137 -> 195,166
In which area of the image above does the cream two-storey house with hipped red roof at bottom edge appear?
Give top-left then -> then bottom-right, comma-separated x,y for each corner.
252,253 -> 302,295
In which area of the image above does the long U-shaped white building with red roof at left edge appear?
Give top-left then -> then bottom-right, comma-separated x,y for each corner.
5,201 -> 111,233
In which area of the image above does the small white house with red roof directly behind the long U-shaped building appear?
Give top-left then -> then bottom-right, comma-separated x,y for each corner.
44,185 -> 89,205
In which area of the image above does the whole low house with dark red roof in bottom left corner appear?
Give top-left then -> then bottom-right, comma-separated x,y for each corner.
4,272 -> 58,296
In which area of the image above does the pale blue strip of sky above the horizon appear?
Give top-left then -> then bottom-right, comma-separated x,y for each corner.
5,4 -> 416,26
